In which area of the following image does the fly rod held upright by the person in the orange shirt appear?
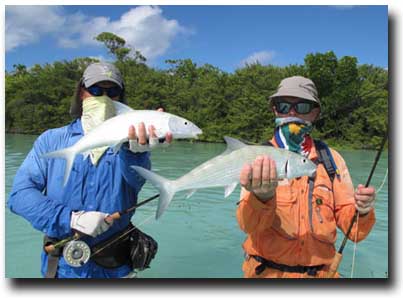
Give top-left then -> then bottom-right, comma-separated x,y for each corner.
326,130 -> 388,278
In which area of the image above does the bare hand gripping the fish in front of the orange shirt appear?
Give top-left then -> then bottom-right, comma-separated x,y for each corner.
240,156 -> 278,201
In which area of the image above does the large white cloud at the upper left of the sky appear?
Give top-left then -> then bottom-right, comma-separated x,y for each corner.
6,6 -> 190,60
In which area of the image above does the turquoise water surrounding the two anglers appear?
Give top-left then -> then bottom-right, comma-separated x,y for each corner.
5,135 -> 388,278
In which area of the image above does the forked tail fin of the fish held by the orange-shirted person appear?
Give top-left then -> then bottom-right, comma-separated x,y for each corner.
131,166 -> 176,219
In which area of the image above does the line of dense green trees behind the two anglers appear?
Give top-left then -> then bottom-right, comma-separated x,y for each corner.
5,32 -> 388,149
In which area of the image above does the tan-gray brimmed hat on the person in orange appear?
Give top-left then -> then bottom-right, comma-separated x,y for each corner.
269,76 -> 320,104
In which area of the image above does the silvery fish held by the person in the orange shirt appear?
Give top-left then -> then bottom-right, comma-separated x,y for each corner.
132,137 -> 316,219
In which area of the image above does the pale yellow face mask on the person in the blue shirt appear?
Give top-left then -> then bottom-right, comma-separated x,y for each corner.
81,96 -> 116,165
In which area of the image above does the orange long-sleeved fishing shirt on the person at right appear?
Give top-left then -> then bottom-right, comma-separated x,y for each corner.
237,138 -> 375,278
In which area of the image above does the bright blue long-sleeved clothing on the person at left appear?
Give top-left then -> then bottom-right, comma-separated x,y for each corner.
8,119 -> 151,278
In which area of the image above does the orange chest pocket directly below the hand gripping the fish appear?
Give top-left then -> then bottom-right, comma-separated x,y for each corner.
272,184 -> 298,239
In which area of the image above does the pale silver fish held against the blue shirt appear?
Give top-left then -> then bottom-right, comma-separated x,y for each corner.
42,101 -> 202,186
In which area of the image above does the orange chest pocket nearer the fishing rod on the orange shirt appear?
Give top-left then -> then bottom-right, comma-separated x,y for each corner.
310,184 -> 337,244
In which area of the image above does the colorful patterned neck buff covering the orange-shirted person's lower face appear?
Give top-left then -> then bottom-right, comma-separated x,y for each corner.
274,117 -> 313,156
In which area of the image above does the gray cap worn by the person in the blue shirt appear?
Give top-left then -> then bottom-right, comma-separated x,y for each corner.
83,62 -> 123,89
